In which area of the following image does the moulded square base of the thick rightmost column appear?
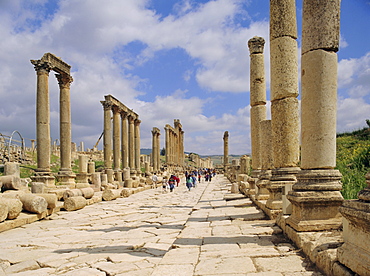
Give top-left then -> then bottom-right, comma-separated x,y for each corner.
286,169 -> 343,232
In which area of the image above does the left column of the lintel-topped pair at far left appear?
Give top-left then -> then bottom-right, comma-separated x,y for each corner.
31,60 -> 54,186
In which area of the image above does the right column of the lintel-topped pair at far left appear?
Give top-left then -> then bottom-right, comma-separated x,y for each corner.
55,74 -> 75,185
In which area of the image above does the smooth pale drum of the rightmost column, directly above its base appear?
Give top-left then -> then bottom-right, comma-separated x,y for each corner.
301,50 -> 338,169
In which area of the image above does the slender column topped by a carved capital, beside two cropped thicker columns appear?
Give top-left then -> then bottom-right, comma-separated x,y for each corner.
248,36 -> 266,194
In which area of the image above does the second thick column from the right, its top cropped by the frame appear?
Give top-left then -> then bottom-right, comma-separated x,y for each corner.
266,0 -> 300,213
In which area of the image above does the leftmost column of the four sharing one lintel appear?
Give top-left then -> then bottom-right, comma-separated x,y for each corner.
101,101 -> 112,169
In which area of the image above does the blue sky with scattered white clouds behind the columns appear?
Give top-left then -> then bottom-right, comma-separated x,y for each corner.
0,0 -> 370,155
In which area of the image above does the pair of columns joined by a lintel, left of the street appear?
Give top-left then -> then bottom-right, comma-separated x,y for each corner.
31,53 -> 76,186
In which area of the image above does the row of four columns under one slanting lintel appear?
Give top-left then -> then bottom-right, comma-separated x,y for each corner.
101,95 -> 141,181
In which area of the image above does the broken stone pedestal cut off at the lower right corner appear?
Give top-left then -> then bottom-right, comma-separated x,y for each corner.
338,200 -> 370,275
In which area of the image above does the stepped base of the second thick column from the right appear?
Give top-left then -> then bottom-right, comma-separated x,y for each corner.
266,167 -> 300,210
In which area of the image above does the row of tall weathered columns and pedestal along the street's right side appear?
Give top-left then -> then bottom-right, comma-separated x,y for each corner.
241,0 -> 370,275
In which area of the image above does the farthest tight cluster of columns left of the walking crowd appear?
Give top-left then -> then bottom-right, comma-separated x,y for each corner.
164,119 -> 185,166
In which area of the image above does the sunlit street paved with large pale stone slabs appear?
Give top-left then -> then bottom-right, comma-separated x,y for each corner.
0,175 -> 322,276
